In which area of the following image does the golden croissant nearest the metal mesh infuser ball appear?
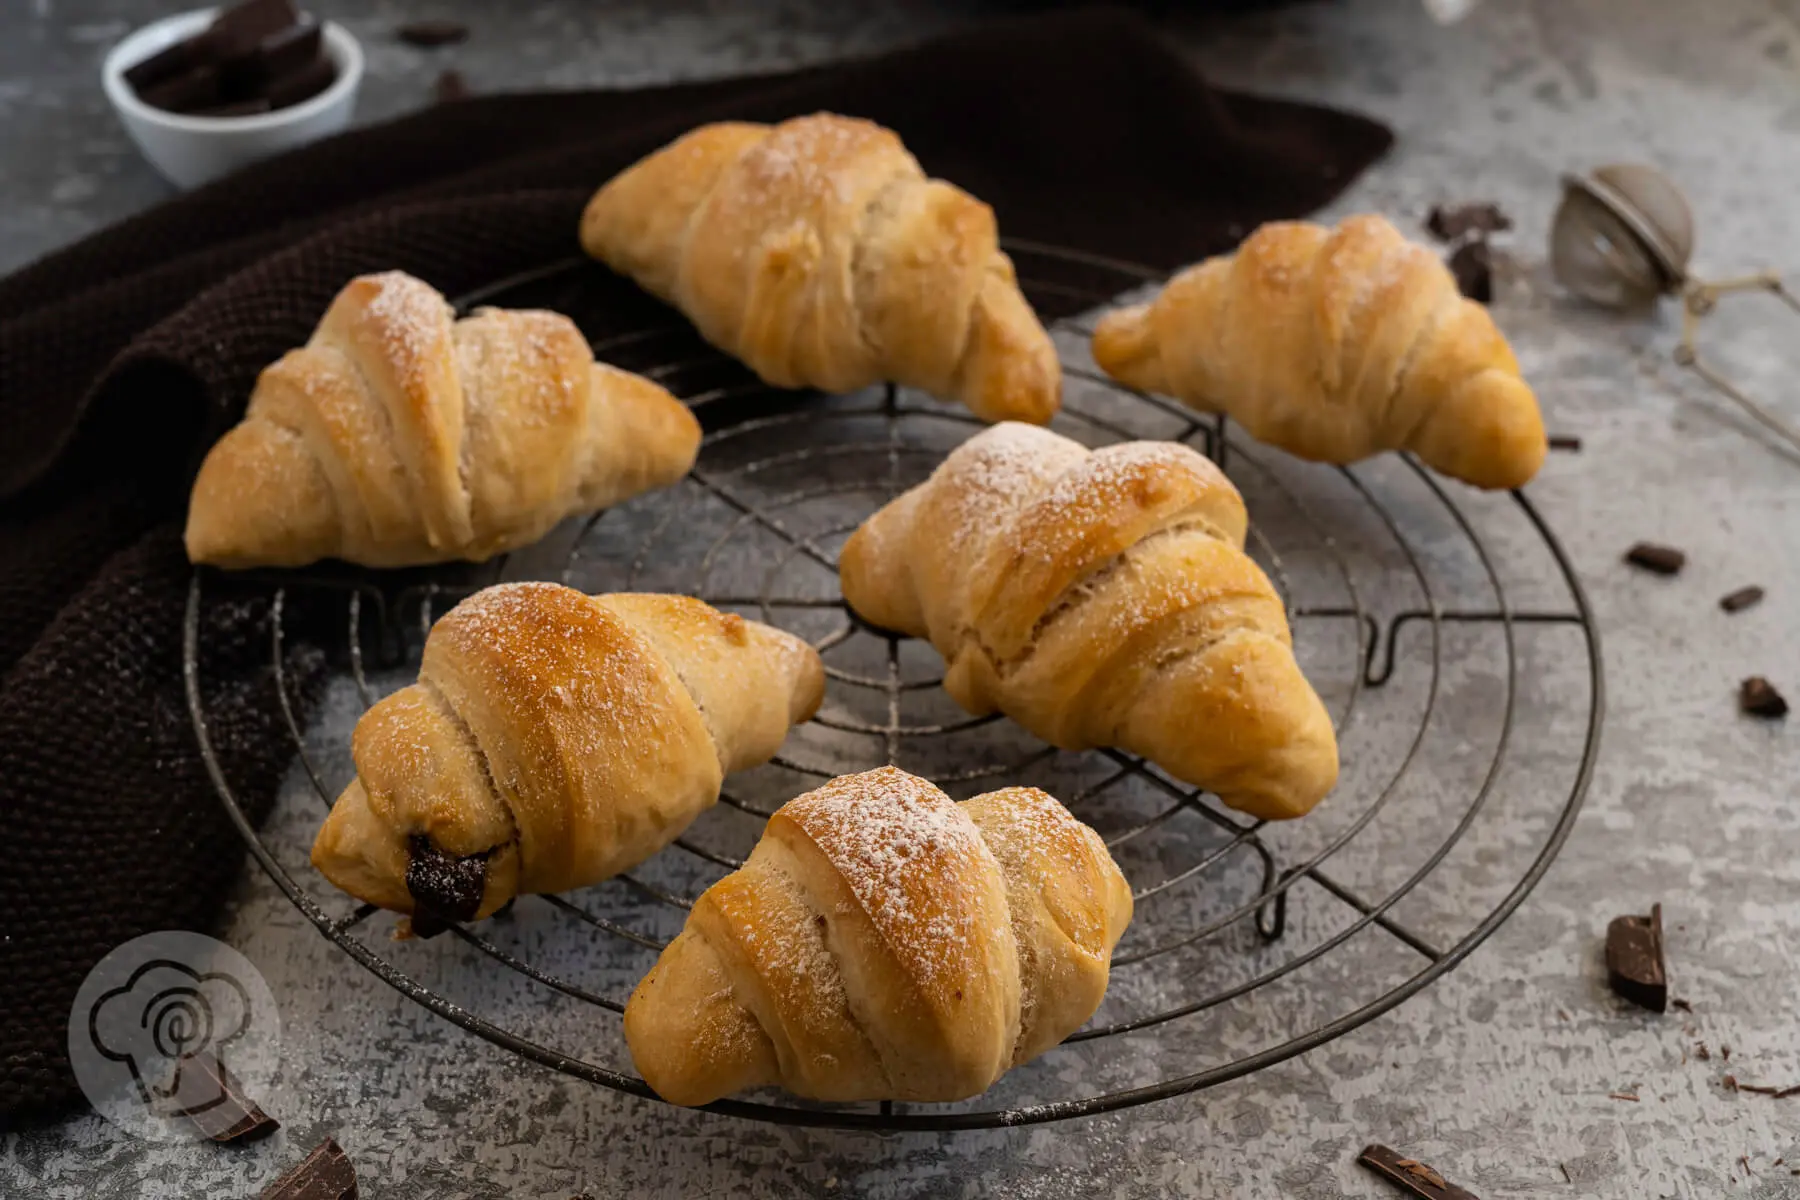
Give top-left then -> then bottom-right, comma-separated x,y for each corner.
1093,216 -> 1548,488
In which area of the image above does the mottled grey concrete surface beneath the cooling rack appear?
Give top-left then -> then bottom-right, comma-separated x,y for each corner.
0,0 -> 1800,1200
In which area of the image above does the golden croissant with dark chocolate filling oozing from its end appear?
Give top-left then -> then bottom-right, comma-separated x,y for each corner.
313,583 -> 824,932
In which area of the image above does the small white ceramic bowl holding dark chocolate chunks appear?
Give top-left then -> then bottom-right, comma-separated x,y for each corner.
101,9 -> 362,187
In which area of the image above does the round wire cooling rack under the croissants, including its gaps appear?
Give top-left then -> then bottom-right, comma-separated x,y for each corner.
184,243 -> 1604,1130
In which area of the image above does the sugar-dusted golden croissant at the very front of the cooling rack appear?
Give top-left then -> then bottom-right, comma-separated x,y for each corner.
625,766 -> 1132,1105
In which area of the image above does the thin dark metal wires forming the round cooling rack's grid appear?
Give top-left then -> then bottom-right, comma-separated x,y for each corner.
185,243 -> 1604,1130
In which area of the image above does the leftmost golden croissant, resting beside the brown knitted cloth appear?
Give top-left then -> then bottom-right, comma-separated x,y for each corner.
187,272 -> 700,567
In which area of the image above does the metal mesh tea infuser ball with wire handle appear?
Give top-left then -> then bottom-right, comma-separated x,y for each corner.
1550,164 -> 1800,450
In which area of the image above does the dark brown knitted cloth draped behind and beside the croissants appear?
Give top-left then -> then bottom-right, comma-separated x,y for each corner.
0,11 -> 1390,1126
